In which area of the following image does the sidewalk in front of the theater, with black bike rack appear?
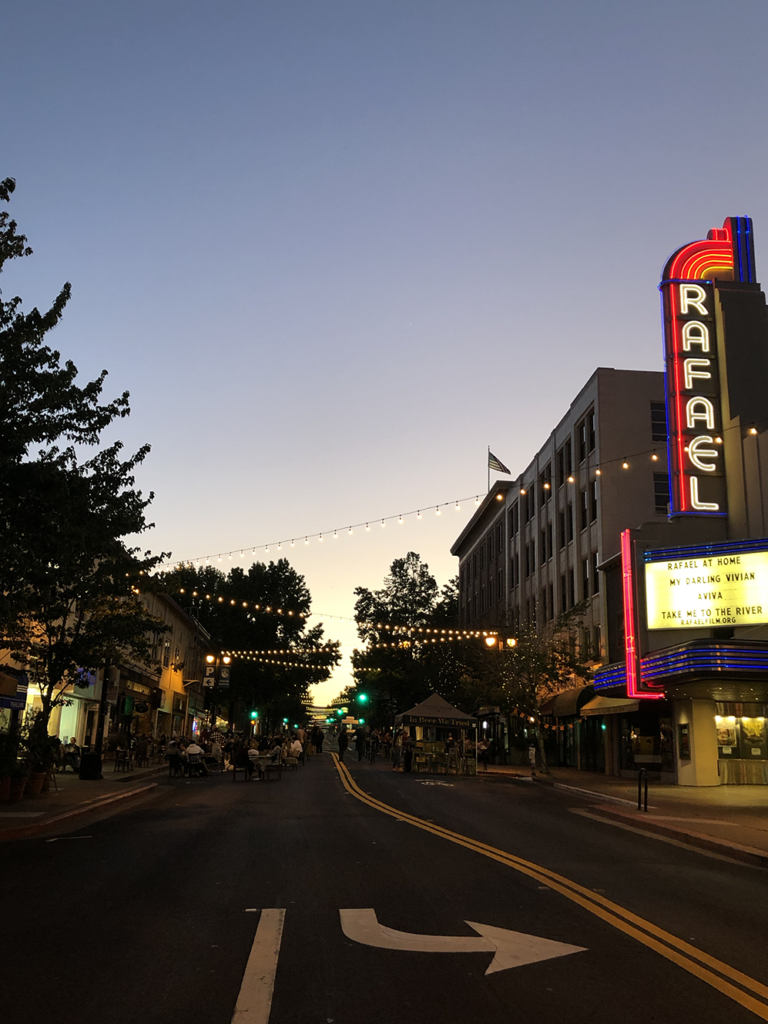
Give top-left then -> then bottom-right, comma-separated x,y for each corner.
479,765 -> 768,867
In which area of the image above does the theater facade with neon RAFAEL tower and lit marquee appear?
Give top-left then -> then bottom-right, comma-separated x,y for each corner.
594,217 -> 768,785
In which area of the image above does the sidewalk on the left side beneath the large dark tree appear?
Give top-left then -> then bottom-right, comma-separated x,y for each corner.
0,761 -> 168,842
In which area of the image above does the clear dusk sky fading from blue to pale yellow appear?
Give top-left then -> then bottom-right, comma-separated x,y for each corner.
0,0 -> 768,699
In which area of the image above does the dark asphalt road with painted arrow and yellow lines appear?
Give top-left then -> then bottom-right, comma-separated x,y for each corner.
0,755 -> 768,1024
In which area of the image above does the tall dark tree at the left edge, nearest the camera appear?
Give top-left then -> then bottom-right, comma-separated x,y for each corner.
0,178 -> 165,726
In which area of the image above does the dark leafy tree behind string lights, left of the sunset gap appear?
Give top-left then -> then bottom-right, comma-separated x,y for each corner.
164,558 -> 340,729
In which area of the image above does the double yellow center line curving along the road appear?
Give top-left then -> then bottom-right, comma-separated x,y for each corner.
333,754 -> 768,1021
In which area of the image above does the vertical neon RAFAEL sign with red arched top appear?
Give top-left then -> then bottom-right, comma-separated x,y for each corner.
659,217 -> 756,516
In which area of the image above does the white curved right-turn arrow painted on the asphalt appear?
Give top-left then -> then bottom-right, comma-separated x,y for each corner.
339,909 -> 586,974
